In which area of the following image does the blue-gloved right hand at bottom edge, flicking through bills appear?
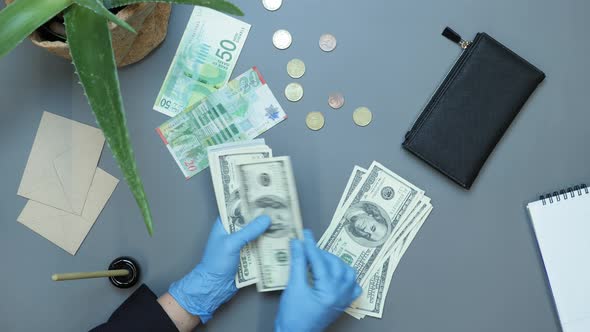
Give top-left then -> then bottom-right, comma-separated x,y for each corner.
275,230 -> 362,332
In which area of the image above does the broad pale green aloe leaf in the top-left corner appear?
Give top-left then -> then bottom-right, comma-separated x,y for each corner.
0,0 -> 72,58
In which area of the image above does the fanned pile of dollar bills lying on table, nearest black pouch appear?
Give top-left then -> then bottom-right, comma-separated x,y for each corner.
318,161 -> 432,319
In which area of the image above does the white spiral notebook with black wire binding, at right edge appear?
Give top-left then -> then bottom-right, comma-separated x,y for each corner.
527,185 -> 590,332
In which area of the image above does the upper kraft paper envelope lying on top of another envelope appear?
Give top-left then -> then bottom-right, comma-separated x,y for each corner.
18,112 -> 105,215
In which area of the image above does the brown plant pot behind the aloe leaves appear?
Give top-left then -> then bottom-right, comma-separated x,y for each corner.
4,0 -> 171,67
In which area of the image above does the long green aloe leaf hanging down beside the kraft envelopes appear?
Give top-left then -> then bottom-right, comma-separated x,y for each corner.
64,4 -> 153,235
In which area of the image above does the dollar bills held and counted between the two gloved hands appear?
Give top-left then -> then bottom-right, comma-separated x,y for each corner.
208,139 -> 302,292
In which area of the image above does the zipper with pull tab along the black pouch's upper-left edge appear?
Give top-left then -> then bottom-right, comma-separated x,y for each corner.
405,27 -> 479,140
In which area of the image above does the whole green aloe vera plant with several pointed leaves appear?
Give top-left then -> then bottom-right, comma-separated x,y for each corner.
0,0 -> 243,235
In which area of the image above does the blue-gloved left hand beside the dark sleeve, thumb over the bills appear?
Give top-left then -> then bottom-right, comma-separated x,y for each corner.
168,216 -> 271,324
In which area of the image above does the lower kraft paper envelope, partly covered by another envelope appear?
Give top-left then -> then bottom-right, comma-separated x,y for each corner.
17,168 -> 119,255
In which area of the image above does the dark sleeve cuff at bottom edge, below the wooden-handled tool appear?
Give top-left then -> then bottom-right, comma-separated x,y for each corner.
91,284 -> 178,332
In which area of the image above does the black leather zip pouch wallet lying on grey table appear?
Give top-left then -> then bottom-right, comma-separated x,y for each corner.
403,28 -> 545,189
